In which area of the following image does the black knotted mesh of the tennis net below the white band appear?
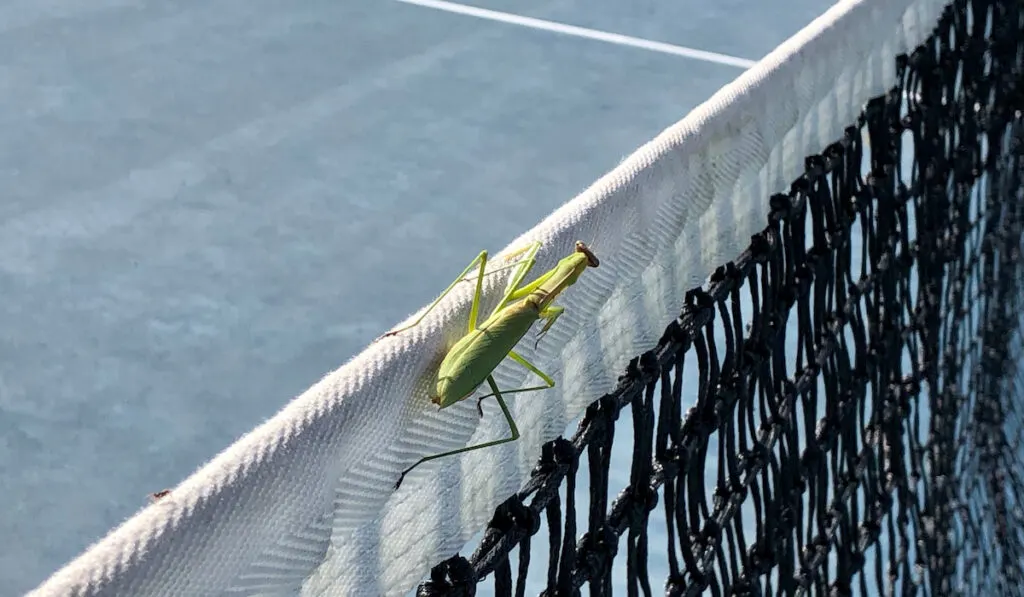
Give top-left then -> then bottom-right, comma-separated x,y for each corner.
418,0 -> 1024,596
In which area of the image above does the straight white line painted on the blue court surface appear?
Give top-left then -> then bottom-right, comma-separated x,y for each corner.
397,0 -> 757,69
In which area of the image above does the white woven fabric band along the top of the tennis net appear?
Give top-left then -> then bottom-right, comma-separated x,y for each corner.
32,0 -> 945,597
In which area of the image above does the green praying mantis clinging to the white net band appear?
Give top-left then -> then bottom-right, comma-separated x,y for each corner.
382,241 -> 600,489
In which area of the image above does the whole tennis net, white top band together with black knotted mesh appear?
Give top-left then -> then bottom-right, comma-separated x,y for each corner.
25,0 -> 1024,597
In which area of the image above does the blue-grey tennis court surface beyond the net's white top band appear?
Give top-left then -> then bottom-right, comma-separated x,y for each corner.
0,0 -> 830,594
